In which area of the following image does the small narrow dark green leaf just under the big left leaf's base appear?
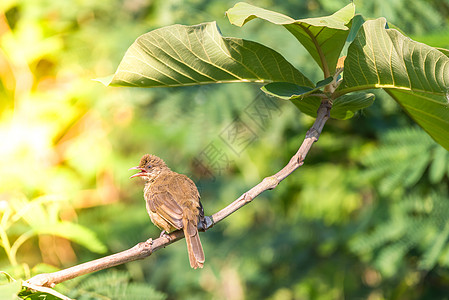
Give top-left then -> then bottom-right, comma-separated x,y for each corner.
261,77 -> 333,100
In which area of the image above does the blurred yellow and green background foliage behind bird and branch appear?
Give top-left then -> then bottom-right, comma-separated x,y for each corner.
0,0 -> 449,300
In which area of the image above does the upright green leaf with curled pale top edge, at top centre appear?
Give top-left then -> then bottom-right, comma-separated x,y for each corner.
226,2 -> 355,77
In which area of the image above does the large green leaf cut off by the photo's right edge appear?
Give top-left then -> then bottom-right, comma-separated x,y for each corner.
334,18 -> 449,150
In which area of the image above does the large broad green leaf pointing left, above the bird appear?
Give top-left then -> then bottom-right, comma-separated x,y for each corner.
102,22 -> 313,87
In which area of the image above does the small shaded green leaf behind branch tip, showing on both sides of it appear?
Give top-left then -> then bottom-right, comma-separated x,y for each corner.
292,93 -> 374,120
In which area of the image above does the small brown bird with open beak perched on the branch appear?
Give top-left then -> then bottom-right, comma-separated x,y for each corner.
130,154 -> 204,269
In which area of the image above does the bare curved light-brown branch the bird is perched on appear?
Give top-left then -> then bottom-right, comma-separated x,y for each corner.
25,99 -> 332,287
